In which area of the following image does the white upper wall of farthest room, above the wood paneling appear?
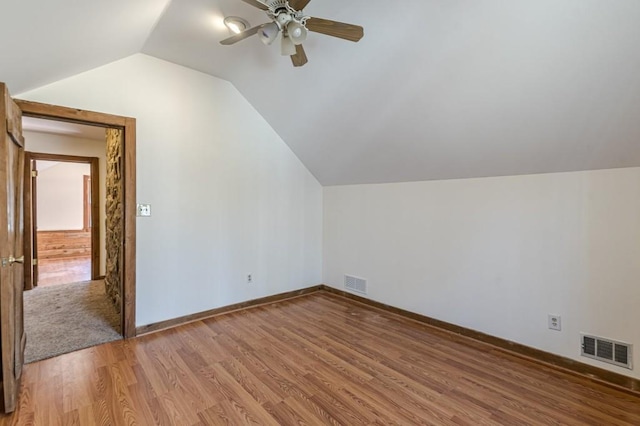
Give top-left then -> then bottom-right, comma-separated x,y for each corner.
36,161 -> 91,231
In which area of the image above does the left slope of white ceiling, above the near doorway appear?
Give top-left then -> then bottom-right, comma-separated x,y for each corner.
0,0 -> 169,93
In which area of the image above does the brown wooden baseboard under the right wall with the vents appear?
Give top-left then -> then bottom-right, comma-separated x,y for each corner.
321,285 -> 640,396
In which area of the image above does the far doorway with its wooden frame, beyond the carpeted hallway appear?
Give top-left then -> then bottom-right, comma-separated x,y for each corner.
23,151 -> 100,290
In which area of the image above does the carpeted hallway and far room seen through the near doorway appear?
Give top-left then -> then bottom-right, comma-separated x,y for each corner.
22,117 -> 122,363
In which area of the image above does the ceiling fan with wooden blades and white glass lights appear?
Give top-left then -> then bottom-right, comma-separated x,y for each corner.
220,0 -> 364,67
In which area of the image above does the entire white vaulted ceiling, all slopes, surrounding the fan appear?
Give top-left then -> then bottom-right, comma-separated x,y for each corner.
0,0 -> 640,185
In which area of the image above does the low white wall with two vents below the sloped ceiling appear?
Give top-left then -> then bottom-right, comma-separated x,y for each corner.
324,168 -> 640,378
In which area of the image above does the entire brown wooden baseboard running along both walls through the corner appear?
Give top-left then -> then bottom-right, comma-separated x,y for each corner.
136,284 -> 640,396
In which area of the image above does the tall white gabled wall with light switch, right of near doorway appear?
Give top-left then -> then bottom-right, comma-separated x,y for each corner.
16,54 -> 322,325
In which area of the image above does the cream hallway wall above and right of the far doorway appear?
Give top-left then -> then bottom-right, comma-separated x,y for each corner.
23,131 -> 107,275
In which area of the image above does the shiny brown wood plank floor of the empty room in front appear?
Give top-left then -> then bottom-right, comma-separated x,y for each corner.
0,292 -> 640,425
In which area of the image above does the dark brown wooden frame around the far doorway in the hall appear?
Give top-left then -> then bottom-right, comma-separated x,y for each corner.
24,151 -> 101,289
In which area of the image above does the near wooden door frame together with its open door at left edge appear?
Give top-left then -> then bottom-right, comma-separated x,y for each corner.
0,82 -> 136,413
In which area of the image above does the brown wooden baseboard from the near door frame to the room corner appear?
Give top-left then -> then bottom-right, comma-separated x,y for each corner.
136,285 -> 324,336
